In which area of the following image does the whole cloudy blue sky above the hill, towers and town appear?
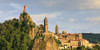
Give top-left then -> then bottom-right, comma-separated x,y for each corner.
0,0 -> 100,33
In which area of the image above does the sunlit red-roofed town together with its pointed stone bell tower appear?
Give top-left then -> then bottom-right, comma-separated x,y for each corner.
55,25 -> 94,49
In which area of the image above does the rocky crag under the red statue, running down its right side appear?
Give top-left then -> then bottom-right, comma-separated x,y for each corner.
20,12 -> 38,40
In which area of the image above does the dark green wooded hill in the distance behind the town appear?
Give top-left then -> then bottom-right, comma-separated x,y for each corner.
82,33 -> 100,43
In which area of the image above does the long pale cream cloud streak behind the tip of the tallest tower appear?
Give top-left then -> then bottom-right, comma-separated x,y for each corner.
30,13 -> 61,22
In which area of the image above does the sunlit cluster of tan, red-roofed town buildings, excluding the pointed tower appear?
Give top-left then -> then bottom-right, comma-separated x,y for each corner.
57,33 -> 92,48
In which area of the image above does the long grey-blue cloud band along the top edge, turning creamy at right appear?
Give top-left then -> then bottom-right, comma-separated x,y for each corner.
39,0 -> 100,10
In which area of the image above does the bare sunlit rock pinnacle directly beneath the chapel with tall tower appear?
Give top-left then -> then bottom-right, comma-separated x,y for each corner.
32,34 -> 59,50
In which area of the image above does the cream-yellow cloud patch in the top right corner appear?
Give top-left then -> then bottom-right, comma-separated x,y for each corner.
79,0 -> 100,9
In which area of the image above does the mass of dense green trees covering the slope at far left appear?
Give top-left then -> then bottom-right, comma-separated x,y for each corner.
0,19 -> 31,50
